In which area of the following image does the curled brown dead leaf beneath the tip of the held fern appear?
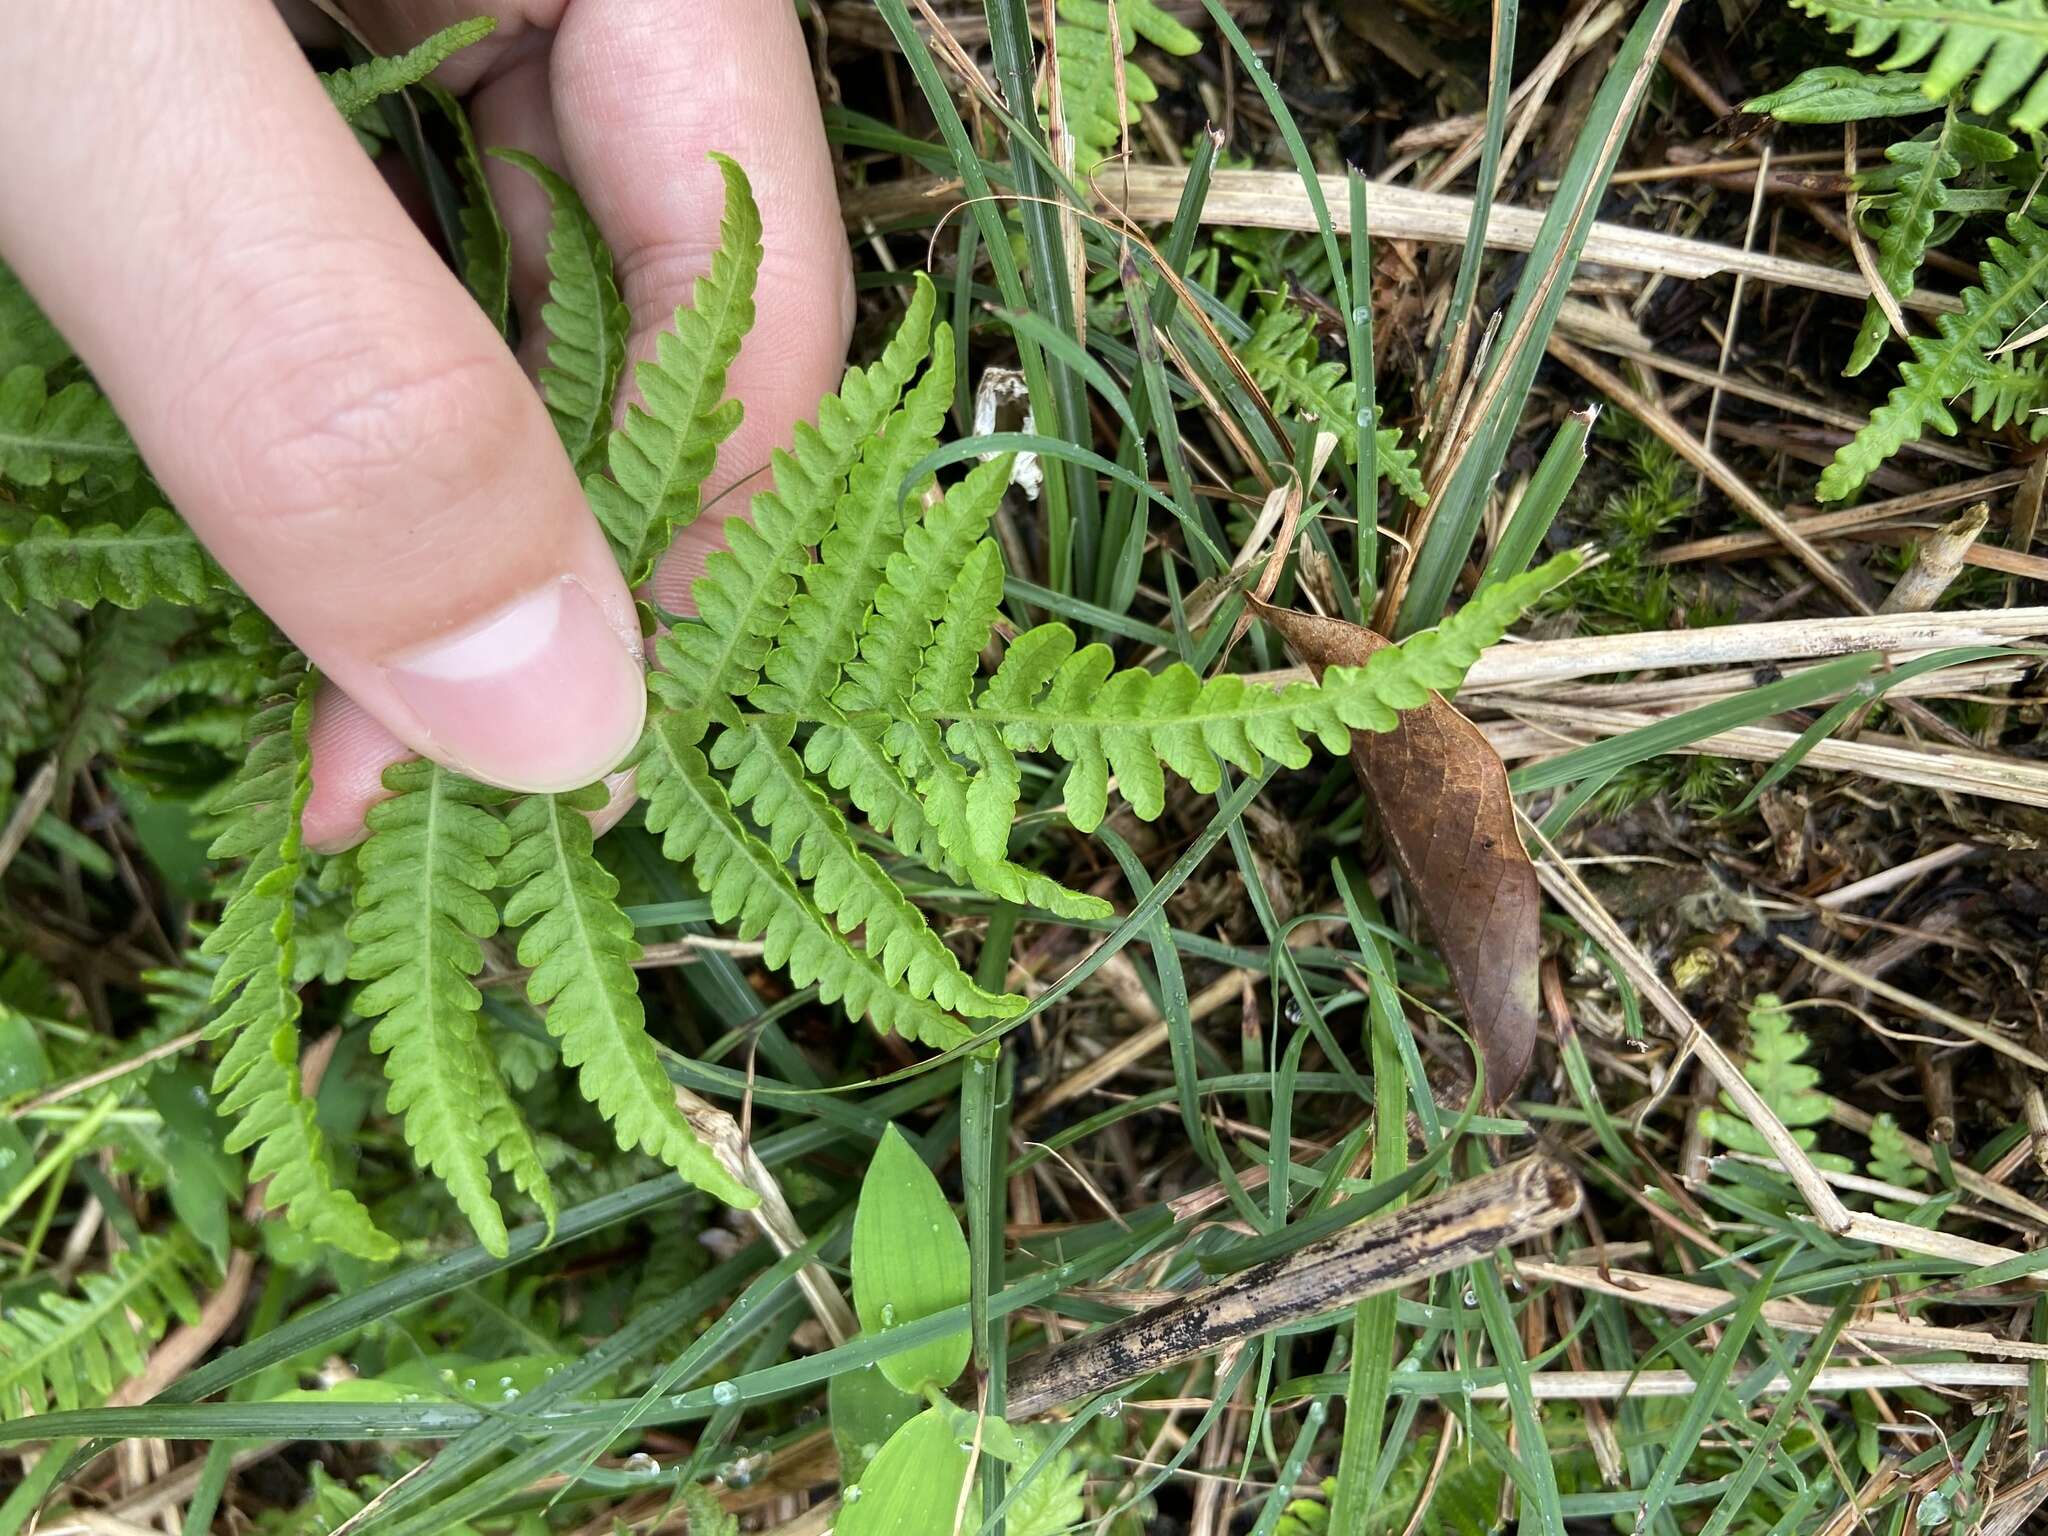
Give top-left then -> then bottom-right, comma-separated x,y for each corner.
1257,602 -> 1542,1104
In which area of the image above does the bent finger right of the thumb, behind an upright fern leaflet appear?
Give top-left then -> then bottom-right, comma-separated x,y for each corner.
549,0 -> 854,608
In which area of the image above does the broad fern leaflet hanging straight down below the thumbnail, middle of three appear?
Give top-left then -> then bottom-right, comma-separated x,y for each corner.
348,762 -> 555,1255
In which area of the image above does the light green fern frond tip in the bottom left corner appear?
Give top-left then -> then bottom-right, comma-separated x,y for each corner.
0,1233 -> 203,1419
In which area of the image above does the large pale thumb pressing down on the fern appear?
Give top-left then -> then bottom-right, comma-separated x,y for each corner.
0,0 -> 645,791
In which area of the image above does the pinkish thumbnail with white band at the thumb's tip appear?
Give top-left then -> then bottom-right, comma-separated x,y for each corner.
385,578 -> 647,793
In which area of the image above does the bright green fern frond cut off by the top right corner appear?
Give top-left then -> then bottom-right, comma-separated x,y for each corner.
1792,0 -> 2048,129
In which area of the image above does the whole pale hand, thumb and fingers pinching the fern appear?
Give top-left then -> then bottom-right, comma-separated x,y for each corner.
0,0 -> 852,850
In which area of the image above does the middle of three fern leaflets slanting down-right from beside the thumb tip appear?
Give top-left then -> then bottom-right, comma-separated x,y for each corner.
711,719 -> 1024,1018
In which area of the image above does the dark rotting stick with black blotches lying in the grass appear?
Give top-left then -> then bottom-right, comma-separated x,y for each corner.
1008,1157 -> 1579,1419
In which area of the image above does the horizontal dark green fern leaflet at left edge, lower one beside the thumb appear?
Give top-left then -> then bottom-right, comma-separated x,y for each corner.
0,506 -> 225,612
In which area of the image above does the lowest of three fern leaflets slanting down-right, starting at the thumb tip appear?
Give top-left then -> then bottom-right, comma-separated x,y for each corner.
635,709 -> 973,1049
